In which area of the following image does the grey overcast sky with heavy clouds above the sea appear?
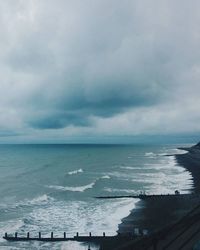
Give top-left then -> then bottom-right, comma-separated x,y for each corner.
0,0 -> 200,142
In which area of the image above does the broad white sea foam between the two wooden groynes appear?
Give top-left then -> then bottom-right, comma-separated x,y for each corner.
20,198 -> 138,239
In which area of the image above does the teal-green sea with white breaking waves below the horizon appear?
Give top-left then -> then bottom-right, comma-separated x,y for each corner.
0,145 -> 193,250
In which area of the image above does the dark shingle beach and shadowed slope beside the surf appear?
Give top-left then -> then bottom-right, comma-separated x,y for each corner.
100,143 -> 200,250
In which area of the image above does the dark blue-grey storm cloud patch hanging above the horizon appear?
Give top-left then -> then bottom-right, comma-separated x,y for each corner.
29,75 -> 159,128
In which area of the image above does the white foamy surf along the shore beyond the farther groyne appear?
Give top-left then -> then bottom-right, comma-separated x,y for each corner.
114,152 -> 193,194
